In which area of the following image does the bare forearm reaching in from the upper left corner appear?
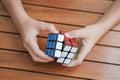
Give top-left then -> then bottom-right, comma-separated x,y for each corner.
2,0 -> 29,27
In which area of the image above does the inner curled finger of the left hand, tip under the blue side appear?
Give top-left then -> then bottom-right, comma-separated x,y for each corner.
23,36 -> 53,61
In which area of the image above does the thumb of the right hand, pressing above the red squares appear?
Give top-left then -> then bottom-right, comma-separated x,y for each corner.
65,29 -> 86,38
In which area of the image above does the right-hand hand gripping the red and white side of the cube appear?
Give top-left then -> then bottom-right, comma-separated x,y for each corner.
63,25 -> 106,67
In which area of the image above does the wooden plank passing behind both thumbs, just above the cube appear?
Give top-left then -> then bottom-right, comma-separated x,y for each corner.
0,18 -> 120,47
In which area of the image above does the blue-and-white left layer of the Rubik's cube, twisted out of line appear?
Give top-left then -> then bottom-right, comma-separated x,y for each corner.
45,33 -> 64,57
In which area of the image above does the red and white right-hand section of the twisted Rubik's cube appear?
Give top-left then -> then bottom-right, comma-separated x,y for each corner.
57,37 -> 78,64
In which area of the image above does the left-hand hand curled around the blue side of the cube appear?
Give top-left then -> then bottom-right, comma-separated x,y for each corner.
16,19 -> 58,62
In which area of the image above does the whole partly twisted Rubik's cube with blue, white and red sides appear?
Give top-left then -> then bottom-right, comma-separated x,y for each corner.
45,32 -> 79,64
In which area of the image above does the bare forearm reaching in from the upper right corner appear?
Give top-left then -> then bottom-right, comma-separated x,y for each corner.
97,0 -> 120,31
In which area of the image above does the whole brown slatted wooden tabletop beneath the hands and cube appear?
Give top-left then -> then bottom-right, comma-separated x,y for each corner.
0,0 -> 120,80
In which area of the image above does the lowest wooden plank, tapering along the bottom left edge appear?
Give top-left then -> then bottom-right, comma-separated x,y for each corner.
0,68 -> 82,80
